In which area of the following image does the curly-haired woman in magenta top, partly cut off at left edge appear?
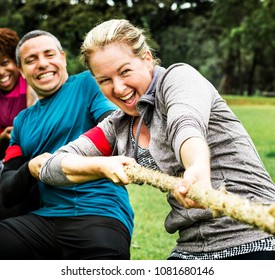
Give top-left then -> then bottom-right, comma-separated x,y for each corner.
0,28 -> 37,220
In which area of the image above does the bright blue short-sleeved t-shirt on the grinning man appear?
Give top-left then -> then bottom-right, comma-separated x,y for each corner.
10,71 -> 134,235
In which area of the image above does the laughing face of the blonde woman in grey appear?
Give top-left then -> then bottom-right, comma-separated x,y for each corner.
89,44 -> 153,116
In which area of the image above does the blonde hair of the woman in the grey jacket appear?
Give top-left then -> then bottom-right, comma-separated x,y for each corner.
80,19 -> 159,68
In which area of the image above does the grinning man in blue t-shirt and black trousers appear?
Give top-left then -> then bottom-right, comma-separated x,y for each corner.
0,30 -> 133,259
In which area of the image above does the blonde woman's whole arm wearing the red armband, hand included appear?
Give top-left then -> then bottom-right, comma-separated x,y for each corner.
39,120 -> 136,186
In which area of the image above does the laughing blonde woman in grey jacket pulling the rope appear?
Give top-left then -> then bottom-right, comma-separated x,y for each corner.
37,20 -> 275,260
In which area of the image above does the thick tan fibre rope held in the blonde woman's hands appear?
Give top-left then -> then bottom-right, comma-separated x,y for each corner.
125,165 -> 275,234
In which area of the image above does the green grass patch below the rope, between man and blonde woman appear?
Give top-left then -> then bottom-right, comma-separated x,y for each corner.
127,185 -> 177,260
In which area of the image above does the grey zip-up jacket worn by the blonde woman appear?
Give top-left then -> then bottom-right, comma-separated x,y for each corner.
40,63 -> 275,253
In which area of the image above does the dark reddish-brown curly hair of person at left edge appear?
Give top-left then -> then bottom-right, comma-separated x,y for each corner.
0,28 -> 19,62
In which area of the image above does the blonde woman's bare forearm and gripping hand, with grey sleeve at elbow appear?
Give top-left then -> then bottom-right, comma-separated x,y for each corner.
39,153 -> 136,185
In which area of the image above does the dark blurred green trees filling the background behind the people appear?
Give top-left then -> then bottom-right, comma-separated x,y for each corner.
0,0 -> 275,96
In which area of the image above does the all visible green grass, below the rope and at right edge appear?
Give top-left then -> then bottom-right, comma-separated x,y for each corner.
127,96 -> 275,260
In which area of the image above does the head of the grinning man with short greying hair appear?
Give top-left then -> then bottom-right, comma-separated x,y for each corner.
16,33 -> 69,99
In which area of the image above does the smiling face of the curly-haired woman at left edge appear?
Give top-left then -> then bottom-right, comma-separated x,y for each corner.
0,56 -> 20,93
